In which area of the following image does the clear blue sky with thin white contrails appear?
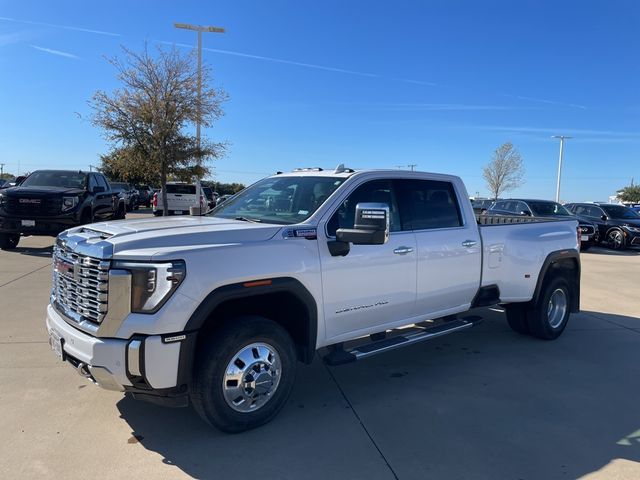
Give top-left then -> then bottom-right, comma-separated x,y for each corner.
0,0 -> 640,201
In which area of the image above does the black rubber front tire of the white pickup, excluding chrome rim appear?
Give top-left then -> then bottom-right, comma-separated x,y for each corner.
191,316 -> 296,433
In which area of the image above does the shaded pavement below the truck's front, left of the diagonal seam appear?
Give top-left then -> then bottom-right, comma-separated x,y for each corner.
117,360 -> 392,479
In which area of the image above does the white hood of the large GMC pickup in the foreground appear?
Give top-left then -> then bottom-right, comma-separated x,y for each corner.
60,216 -> 282,259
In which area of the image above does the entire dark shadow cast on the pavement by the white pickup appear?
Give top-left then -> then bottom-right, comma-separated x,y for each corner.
117,310 -> 640,480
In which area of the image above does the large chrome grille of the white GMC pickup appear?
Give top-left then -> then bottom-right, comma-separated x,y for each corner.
52,244 -> 110,324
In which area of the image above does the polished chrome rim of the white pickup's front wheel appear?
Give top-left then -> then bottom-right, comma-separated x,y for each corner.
222,343 -> 282,413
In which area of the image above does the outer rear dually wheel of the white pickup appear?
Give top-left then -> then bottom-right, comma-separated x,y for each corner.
527,277 -> 571,340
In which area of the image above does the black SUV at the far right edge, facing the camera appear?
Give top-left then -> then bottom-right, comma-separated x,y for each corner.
566,203 -> 640,249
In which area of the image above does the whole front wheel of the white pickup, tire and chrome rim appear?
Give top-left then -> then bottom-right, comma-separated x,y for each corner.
191,316 -> 296,433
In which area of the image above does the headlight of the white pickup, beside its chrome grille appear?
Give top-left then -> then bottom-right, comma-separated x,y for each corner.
113,260 -> 187,313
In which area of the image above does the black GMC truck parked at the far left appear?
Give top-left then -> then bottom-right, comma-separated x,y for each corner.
0,170 -> 124,250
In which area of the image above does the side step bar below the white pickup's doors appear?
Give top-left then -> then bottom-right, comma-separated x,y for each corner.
323,316 -> 482,365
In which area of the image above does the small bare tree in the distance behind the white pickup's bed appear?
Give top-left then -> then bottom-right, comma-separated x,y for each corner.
482,142 -> 524,200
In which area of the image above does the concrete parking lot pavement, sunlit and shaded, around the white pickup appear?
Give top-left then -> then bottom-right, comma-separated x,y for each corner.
0,214 -> 640,480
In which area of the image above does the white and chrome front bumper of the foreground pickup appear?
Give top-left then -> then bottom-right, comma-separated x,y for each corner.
46,305 -> 196,405
